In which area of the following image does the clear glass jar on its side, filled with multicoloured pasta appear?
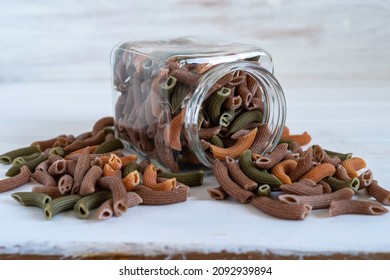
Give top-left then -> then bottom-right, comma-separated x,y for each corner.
111,38 -> 286,172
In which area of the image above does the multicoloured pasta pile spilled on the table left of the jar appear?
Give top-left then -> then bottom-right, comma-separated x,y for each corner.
0,117 -> 204,220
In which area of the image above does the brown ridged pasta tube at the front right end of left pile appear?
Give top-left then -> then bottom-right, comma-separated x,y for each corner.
134,185 -> 190,205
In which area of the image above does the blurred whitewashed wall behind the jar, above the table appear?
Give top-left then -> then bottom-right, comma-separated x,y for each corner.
0,0 -> 390,88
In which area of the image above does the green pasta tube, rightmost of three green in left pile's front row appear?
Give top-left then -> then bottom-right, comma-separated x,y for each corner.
73,191 -> 112,219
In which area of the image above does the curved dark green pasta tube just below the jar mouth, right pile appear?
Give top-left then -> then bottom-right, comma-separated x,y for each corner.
238,150 -> 282,190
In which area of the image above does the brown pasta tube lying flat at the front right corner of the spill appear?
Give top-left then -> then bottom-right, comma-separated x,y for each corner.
329,199 -> 389,217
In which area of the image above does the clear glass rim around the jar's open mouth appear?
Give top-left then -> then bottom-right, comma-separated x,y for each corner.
184,61 -> 287,168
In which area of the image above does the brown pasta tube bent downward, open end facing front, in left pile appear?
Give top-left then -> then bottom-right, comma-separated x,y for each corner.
98,176 -> 128,217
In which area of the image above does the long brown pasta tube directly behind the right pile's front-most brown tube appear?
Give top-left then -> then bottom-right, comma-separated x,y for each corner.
278,188 -> 355,209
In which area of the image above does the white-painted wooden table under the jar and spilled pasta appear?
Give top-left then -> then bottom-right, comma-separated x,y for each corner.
0,81 -> 390,259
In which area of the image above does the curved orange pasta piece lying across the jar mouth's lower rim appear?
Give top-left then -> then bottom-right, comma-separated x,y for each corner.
210,128 -> 257,160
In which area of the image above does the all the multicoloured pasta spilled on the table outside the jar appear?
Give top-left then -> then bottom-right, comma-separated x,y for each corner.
0,117 -> 390,220
